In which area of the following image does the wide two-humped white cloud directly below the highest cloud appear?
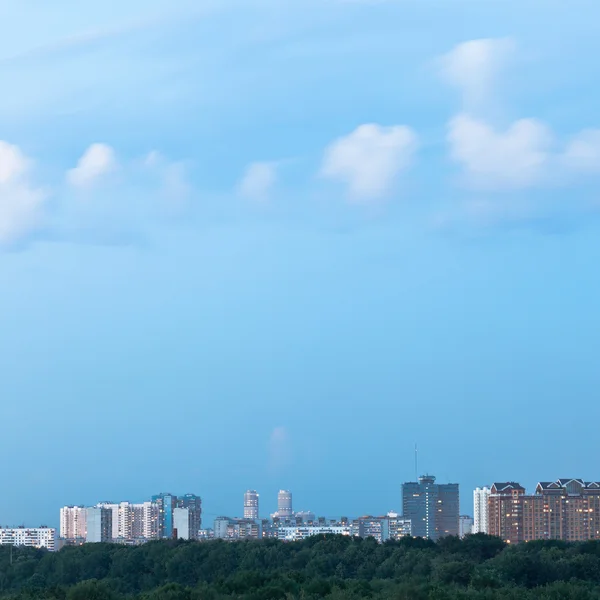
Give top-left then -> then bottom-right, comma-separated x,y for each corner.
448,114 -> 552,188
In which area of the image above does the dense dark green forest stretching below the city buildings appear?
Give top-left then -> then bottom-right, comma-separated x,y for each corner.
0,534 -> 600,600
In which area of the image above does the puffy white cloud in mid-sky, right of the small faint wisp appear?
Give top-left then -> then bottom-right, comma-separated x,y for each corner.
321,123 -> 417,201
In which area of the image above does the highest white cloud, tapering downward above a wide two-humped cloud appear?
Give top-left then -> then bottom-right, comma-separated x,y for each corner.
440,38 -> 515,110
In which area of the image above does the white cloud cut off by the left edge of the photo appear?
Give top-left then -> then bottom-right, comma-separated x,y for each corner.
0,140 -> 47,245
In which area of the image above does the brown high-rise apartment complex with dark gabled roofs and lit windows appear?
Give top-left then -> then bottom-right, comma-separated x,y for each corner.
489,479 -> 600,543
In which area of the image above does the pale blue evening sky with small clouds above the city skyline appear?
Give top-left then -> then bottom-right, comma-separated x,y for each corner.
0,0 -> 600,525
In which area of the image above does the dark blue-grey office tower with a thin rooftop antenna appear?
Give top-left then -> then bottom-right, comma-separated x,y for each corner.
402,475 -> 459,540
